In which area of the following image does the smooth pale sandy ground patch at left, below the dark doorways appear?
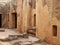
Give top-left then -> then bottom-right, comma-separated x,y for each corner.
0,29 -> 19,39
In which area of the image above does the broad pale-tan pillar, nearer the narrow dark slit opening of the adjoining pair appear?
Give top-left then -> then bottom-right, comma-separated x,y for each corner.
23,0 -> 31,33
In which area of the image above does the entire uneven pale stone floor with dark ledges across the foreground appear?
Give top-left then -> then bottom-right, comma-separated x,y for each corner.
0,29 -> 52,45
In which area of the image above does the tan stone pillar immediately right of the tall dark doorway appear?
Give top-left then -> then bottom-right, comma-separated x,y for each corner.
17,0 -> 23,33
